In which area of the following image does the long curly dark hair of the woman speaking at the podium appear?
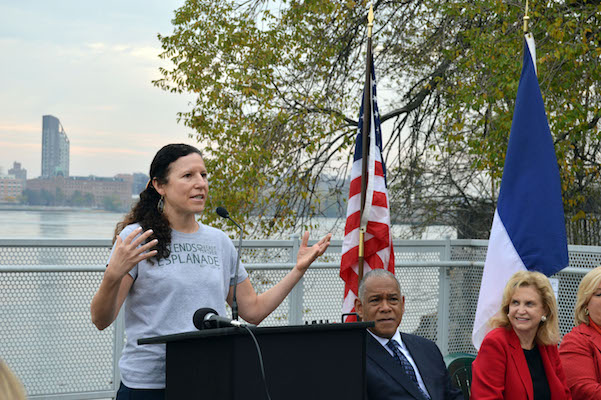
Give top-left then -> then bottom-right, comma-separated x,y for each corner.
113,143 -> 202,261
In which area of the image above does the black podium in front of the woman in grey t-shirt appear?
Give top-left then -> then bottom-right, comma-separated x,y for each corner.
138,322 -> 373,400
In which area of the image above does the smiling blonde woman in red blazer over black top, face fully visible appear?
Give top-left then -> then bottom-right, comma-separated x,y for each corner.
471,271 -> 572,400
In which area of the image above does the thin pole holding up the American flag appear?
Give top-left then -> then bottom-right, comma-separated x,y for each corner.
357,5 -> 374,290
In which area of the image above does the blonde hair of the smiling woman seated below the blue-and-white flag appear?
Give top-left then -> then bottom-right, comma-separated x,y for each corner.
488,271 -> 559,345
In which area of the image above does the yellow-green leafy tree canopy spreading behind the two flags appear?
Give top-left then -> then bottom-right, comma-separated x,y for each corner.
155,0 -> 601,237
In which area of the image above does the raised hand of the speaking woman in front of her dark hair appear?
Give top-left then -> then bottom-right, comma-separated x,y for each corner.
105,228 -> 158,280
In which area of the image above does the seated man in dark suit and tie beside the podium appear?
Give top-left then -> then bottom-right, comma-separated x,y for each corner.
355,269 -> 463,400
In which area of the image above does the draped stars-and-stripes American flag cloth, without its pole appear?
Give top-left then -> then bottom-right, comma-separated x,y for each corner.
340,58 -> 394,322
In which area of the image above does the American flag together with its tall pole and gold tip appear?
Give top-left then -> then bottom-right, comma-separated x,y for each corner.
340,5 -> 394,322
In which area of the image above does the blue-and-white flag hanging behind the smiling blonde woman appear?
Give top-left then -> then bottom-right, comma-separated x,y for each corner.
472,34 -> 568,349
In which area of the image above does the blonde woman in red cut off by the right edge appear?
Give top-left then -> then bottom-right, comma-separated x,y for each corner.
559,267 -> 601,400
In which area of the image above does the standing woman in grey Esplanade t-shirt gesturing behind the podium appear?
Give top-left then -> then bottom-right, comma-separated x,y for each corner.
91,144 -> 331,400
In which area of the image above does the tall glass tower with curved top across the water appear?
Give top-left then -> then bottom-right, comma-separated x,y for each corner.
42,115 -> 69,178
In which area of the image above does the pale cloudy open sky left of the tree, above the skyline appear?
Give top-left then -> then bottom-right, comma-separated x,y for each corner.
0,0 -> 196,178
